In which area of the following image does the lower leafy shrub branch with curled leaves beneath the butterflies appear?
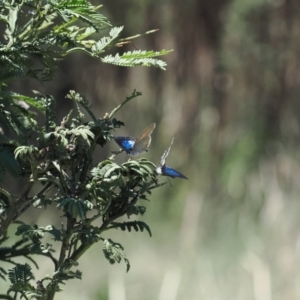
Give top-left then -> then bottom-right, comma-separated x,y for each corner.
0,91 -> 165,299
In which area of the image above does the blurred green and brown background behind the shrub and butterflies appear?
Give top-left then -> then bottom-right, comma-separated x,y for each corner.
6,0 -> 300,300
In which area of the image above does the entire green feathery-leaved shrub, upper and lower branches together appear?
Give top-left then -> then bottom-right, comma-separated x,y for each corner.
0,0 -> 176,300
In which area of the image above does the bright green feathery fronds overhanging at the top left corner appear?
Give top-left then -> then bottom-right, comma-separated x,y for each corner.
0,0 -> 170,84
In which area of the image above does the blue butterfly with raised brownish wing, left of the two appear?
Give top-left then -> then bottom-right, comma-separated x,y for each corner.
114,123 -> 155,155
